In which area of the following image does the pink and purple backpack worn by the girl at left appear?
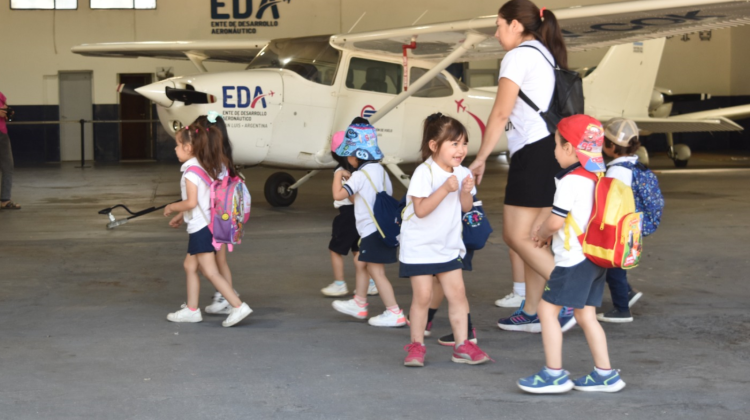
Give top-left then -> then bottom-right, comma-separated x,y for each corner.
185,166 -> 251,252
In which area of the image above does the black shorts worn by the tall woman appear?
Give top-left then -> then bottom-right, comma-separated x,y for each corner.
505,134 -> 561,207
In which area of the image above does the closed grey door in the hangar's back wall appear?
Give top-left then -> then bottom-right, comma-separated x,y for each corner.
58,71 -> 94,161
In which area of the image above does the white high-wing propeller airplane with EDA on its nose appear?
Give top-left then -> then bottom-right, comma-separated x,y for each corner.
72,0 -> 750,206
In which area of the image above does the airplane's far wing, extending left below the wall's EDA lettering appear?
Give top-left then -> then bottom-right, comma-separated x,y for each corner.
71,40 -> 268,63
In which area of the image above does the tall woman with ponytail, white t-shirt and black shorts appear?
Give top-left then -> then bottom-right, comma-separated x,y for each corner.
469,0 -> 568,330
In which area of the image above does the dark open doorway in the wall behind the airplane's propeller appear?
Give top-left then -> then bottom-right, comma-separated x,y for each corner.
120,73 -> 154,161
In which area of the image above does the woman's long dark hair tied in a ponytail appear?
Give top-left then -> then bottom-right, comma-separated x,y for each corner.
497,0 -> 568,69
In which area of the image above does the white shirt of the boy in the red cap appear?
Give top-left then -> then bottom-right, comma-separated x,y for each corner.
552,163 -> 596,267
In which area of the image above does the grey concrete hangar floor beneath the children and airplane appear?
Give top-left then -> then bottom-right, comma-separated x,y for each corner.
0,155 -> 750,419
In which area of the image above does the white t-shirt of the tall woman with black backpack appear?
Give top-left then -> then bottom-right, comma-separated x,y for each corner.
500,40 -> 555,156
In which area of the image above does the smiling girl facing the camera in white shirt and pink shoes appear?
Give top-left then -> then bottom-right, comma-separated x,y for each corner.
399,113 -> 490,366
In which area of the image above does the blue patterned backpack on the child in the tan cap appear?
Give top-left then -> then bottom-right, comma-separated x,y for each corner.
613,162 -> 664,236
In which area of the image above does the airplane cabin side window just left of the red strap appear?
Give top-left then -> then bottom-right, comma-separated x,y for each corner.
346,57 -> 403,95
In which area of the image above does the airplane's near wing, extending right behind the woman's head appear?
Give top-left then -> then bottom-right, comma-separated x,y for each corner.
331,0 -> 750,61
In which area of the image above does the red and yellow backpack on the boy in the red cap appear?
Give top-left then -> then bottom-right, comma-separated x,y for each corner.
564,168 -> 643,270
